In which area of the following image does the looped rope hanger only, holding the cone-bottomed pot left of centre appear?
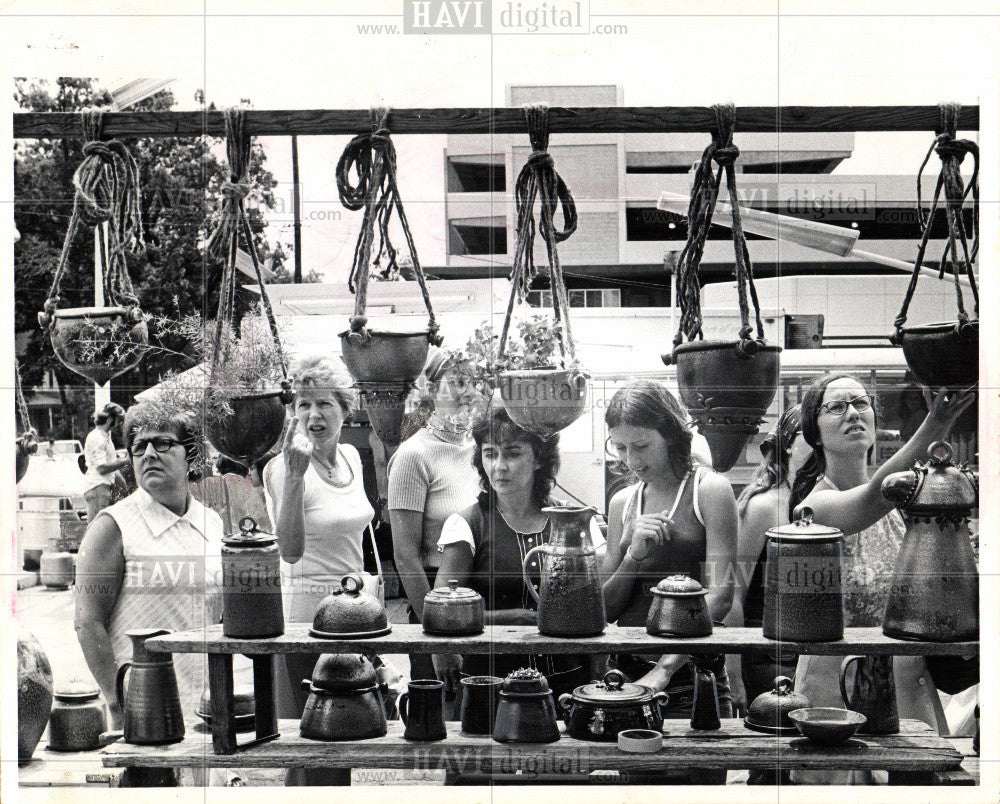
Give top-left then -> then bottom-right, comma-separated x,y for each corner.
337,107 -> 442,346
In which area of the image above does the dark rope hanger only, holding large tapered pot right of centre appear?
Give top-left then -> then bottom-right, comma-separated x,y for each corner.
674,104 -> 764,354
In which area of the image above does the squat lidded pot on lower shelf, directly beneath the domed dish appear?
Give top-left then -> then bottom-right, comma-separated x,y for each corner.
299,653 -> 388,741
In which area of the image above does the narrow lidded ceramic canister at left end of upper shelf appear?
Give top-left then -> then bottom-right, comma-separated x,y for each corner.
222,516 -> 285,639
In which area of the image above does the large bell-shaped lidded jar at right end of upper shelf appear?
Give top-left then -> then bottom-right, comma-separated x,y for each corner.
882,441 -> 979,642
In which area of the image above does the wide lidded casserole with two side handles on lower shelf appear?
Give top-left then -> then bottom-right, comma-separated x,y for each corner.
559,670 -> 669,743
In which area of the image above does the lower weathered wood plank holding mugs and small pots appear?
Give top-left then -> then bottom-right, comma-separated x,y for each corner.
102,719 -> 962,774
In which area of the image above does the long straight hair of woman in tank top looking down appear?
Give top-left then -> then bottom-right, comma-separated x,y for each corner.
604,380 -> 694,478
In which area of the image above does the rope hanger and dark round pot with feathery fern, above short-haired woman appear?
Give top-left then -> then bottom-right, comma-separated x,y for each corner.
205,109 -> 293,466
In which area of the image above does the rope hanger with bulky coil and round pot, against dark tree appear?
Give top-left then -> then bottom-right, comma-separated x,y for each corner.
38,109 -> 149,385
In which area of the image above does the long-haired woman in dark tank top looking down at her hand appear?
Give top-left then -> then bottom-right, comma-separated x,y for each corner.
602,380 -> 737,781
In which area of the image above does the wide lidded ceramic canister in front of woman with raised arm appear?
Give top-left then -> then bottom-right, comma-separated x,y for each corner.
764,509 -> 844,642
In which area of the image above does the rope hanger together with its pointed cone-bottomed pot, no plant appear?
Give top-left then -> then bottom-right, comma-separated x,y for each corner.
337,108 -> 441,451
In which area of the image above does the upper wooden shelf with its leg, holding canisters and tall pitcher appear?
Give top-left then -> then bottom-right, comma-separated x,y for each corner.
146,623 -> 979,772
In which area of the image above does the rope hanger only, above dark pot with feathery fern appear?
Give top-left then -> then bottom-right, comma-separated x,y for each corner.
206,108 -> 288,385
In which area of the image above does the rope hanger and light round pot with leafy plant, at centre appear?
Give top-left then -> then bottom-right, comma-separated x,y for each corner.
497,105 -> 589,437
